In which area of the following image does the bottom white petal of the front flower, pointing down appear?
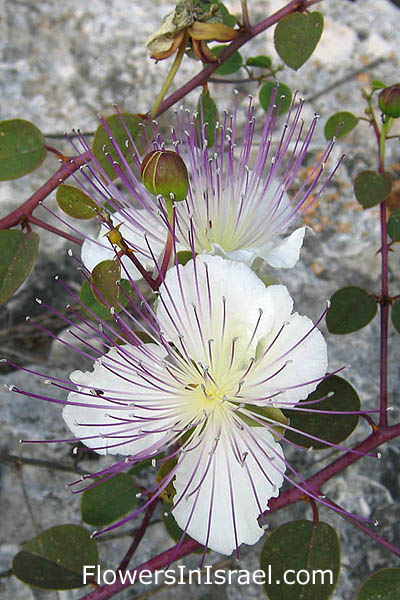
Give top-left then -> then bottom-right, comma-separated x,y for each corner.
172,427 -> 285,554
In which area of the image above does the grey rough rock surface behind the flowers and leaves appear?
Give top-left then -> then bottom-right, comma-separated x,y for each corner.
0,0 -> 400,600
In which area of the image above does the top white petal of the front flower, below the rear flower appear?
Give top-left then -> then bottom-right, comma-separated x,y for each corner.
157,254 -> 274,364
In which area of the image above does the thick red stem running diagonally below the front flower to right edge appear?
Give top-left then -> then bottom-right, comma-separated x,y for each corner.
81,424 -> 400,600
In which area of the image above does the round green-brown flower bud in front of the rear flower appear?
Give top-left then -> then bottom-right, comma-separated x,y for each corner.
141,150 -> 189,202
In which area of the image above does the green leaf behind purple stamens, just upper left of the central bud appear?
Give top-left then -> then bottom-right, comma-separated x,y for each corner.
92,113 -> 141,180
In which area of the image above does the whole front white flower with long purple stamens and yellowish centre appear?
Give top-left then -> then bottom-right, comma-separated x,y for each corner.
63,255 -> 327,554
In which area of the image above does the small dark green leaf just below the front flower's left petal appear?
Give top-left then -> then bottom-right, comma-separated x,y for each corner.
81,473 -> 139,527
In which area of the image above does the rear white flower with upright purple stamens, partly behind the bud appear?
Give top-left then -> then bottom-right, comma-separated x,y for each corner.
77,102 -> 333,276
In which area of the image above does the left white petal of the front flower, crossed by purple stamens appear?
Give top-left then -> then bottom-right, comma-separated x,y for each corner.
62,344 -> 172,455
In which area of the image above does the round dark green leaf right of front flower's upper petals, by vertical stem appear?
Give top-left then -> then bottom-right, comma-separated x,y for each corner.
326,286 -> 377,334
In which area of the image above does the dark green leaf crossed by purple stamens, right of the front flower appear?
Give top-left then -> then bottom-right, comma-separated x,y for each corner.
283,375 -> 360,450
